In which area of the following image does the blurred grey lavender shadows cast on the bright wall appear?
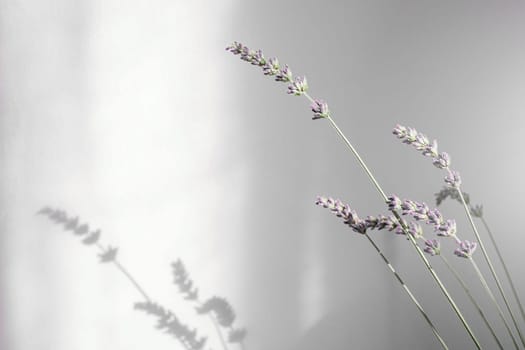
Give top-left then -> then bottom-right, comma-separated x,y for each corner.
37,207 -> 246,350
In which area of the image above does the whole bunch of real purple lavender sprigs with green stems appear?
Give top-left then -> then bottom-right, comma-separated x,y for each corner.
226,42 -> 525,349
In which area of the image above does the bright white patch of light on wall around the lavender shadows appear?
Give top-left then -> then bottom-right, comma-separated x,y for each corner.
0,0 -> 239,350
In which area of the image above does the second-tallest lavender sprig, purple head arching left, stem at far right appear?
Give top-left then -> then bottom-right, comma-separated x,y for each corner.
392,124 -> 525,348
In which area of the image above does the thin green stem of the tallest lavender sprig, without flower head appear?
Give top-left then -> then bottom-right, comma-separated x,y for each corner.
304,93 -> 481,349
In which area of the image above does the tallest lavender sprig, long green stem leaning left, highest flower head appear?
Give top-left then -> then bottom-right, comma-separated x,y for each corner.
226,42 -> 482,349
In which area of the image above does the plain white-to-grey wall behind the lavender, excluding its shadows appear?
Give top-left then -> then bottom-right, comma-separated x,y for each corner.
0,0 -> 525,350
